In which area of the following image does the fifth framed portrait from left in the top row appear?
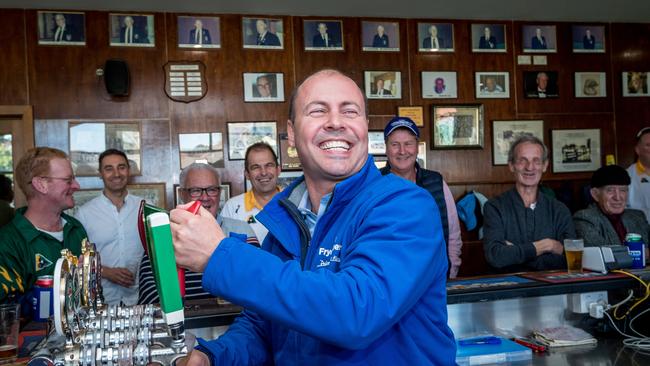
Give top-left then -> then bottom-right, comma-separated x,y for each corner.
302,19 -> 344,51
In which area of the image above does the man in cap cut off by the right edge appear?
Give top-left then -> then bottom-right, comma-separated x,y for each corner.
627,127 -> 650,221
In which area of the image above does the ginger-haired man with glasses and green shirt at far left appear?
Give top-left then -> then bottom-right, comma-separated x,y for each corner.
0,147 -> 86,302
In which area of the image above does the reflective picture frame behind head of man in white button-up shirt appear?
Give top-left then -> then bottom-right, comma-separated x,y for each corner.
68,121 -> 142,177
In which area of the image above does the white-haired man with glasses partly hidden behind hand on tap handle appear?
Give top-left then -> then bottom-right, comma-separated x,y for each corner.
138,163 -> 259,304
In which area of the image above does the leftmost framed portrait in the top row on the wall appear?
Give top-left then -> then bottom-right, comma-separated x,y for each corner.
37,11 -> 86,46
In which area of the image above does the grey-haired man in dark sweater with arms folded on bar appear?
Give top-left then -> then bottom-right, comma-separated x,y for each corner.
483,135 -> 576,272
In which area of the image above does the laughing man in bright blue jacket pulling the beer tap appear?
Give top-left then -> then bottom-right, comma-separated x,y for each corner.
171,70 -> 456,365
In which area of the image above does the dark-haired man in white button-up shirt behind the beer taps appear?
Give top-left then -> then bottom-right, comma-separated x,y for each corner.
77,149 -> 144,305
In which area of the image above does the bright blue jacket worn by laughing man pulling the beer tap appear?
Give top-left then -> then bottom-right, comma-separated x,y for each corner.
197,158 -> 456,365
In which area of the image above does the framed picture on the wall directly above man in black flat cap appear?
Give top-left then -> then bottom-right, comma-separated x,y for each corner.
551,128 -> 601,173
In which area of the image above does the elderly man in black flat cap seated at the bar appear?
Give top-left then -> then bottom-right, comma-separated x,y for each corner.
573,165 -> 650,246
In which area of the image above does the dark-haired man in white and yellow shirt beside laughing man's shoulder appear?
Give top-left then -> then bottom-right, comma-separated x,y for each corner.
220,142 -> 280,245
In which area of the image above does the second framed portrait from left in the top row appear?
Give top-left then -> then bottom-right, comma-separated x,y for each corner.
108,13 -> 156,47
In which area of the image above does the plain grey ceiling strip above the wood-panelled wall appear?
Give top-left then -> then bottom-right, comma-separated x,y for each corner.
0,0 -> 650,23
